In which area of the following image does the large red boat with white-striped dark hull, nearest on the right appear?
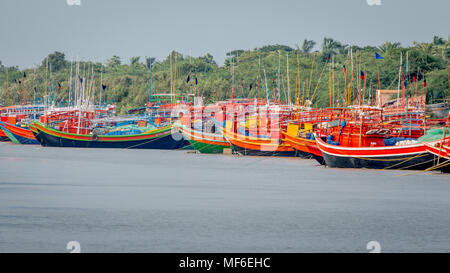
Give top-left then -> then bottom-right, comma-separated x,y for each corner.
316,109 -> 448,170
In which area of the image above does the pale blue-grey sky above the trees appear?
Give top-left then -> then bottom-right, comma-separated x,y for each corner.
0,0 -> 450,68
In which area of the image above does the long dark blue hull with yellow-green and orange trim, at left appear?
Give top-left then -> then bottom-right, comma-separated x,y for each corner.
30,122 -> 185,149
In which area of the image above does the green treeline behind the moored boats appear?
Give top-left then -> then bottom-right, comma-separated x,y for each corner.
0,37 -> 450,113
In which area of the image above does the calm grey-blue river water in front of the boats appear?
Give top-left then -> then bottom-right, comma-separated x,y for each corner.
0,143 -> 450,252
